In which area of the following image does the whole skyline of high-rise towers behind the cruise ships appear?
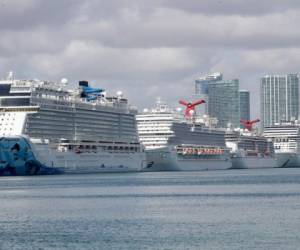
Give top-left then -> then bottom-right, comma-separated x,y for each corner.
195,72 -> 299,128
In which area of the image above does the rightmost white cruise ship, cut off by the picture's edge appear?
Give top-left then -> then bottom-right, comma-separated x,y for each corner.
263,122 -> 300,168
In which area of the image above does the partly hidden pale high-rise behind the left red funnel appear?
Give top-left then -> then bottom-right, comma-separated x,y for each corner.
195,72 -> 223,115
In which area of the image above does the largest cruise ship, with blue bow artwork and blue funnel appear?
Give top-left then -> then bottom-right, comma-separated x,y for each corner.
0,73 -> 145,175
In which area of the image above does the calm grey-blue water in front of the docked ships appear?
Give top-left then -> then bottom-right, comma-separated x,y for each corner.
0,169 -> 300,250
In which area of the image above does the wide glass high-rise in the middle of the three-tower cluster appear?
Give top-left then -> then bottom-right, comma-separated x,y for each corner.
208,79 -> 240,128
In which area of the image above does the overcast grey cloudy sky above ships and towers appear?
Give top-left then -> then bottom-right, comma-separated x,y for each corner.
0,0 -> 300,118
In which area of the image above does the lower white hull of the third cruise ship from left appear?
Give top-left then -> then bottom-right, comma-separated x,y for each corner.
232,156 -> 279,169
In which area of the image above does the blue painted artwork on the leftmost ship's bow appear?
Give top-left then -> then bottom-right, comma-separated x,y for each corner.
0,136 -> 59,176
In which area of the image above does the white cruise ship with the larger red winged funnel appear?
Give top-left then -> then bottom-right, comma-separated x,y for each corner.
137,101 -> 232,171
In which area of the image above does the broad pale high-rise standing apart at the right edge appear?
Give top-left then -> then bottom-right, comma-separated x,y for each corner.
260,74 -> 299,127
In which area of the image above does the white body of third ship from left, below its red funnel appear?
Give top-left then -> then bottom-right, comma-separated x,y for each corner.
226,130 -> 279,169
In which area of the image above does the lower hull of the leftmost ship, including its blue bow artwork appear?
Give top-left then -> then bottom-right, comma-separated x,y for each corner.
0,136 -> 146,175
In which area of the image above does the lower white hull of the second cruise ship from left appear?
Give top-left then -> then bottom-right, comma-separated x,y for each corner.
144,147 -> 232,171
